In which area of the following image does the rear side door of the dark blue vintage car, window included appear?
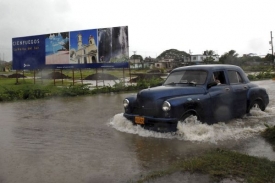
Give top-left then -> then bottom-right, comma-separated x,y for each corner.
227,70 -> 248,117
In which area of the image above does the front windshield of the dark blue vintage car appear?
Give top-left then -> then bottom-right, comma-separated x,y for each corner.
164,70 -> 207,85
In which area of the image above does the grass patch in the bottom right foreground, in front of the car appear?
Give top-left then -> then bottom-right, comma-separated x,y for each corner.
137,149 -> 275,183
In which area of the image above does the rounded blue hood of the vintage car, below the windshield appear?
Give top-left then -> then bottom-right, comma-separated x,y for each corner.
137,86 -> 205,100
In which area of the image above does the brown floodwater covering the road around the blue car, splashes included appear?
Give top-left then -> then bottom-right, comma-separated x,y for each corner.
0,80 -> 275,183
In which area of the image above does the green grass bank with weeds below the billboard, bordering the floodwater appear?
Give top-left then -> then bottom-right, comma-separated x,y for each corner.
0,71 -> 162,102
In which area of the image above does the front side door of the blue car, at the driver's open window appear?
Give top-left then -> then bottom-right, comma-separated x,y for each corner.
208,70 -> 232,121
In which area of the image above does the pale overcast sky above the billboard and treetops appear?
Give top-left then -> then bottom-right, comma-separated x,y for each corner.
0,0 -> 275,61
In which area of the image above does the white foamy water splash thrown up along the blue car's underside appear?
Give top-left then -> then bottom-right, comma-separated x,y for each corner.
109,107 -> 275,143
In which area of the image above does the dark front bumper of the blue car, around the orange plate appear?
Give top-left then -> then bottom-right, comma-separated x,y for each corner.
123,113 -> 178,132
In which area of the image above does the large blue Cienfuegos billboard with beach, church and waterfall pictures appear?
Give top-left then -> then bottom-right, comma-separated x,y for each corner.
12,26 -> 129,70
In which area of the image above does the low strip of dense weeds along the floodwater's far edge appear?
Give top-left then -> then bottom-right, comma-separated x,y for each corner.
0,78 -> 163,102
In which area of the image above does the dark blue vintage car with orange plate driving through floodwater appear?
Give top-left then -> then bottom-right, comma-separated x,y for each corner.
123,65 -> 269,132
